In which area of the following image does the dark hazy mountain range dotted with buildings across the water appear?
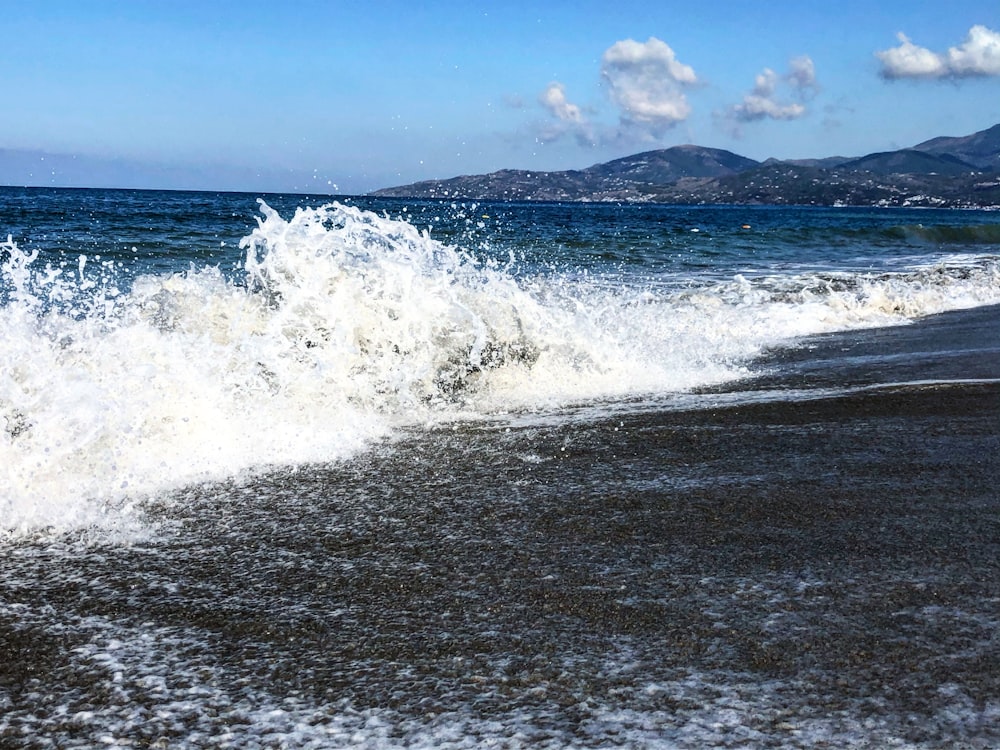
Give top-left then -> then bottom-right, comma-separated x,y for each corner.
372,124 -> 1000,208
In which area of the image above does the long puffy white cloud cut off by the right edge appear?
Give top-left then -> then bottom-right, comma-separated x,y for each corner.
875,25 -> 1000,80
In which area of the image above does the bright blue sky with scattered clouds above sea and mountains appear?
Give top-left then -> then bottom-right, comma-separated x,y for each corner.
0,0 -> 1000,194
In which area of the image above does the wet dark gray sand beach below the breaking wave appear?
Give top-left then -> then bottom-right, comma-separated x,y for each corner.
0,308 -> 1000,748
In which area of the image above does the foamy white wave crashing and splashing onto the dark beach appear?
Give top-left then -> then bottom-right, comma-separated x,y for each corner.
0,202 -> 1000,538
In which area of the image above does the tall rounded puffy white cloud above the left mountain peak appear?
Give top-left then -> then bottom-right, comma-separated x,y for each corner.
601,37 -> 698,137
